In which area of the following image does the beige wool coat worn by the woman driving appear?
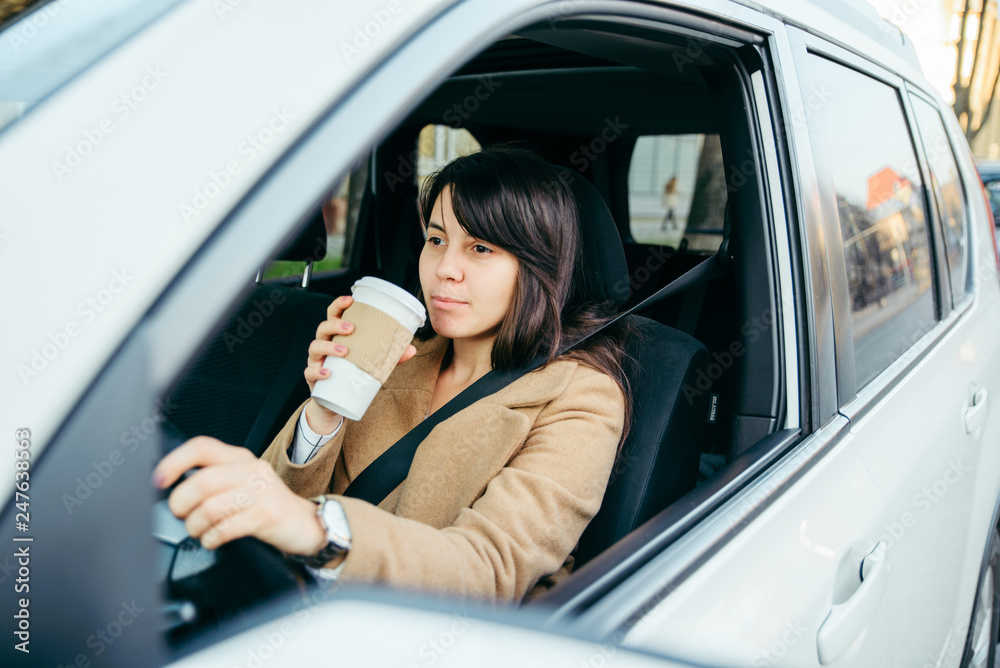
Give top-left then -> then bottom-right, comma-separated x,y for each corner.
262,337 -> 624,602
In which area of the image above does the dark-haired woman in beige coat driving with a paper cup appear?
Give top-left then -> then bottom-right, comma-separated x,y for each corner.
154,148 -> 628,602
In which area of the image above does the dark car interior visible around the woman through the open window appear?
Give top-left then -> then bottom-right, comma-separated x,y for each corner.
156,10 -> 785,648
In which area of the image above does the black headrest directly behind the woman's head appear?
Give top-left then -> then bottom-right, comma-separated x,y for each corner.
552,165 -> 631,306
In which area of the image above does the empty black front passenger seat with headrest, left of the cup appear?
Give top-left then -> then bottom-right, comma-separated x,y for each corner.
162,212 -> 332,455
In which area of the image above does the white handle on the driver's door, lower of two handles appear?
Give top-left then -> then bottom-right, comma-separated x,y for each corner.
816,543 -> 889,664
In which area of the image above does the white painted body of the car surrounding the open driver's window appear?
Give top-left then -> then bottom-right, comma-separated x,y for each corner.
0,0 -> 1000,668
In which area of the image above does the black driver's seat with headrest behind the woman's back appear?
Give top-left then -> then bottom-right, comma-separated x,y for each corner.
556,167 -> 709,566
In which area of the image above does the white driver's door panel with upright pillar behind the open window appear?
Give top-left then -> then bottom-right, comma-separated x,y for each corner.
544,3 -> 894,668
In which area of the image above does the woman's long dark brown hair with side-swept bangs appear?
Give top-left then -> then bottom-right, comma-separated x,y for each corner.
417,146 -> 632,448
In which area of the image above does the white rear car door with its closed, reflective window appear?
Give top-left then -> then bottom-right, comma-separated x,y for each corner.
784,28 -> 997,666
